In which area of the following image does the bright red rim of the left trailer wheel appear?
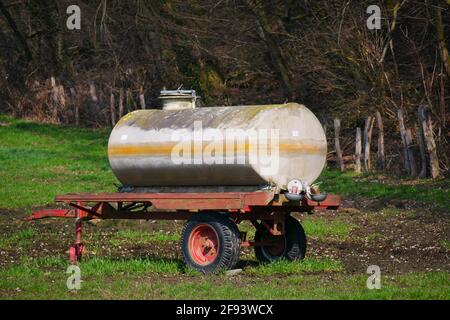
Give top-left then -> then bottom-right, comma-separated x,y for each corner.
189,224 -> 219,266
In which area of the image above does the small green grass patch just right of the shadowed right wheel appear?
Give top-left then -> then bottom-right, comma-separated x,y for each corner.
302,219 -> 355,240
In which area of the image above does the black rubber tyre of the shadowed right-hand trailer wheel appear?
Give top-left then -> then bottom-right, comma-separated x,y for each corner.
255,216 -> 306,263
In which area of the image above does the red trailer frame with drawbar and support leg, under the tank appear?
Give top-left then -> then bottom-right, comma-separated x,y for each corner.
27,190 -> 340,263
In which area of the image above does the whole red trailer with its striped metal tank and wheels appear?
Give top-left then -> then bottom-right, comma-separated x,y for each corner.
28,90 -> 340,274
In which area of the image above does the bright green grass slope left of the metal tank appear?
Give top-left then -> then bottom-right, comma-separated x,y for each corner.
0,115 -> 117,208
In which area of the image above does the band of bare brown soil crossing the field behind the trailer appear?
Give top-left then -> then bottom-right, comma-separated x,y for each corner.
0,198 -> 450,274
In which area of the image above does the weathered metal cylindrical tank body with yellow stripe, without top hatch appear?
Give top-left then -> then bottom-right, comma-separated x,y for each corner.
108,103 -> 327,189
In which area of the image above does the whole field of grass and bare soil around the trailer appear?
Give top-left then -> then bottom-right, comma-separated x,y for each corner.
0,116 -> 450,299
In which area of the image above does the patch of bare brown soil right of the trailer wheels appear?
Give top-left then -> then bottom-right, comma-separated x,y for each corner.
309,200 -> 450,274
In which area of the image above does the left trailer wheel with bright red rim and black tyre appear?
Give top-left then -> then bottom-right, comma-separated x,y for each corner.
181,213 -> 240,274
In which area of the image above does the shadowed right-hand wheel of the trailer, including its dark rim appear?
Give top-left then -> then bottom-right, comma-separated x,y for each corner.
255,216 -> 306,262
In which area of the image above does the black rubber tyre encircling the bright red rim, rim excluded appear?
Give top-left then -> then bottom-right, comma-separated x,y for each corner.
180,212 -> 241,274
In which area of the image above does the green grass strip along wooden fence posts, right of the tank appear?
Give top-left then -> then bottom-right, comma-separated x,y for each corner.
318,169 -> 450,209
